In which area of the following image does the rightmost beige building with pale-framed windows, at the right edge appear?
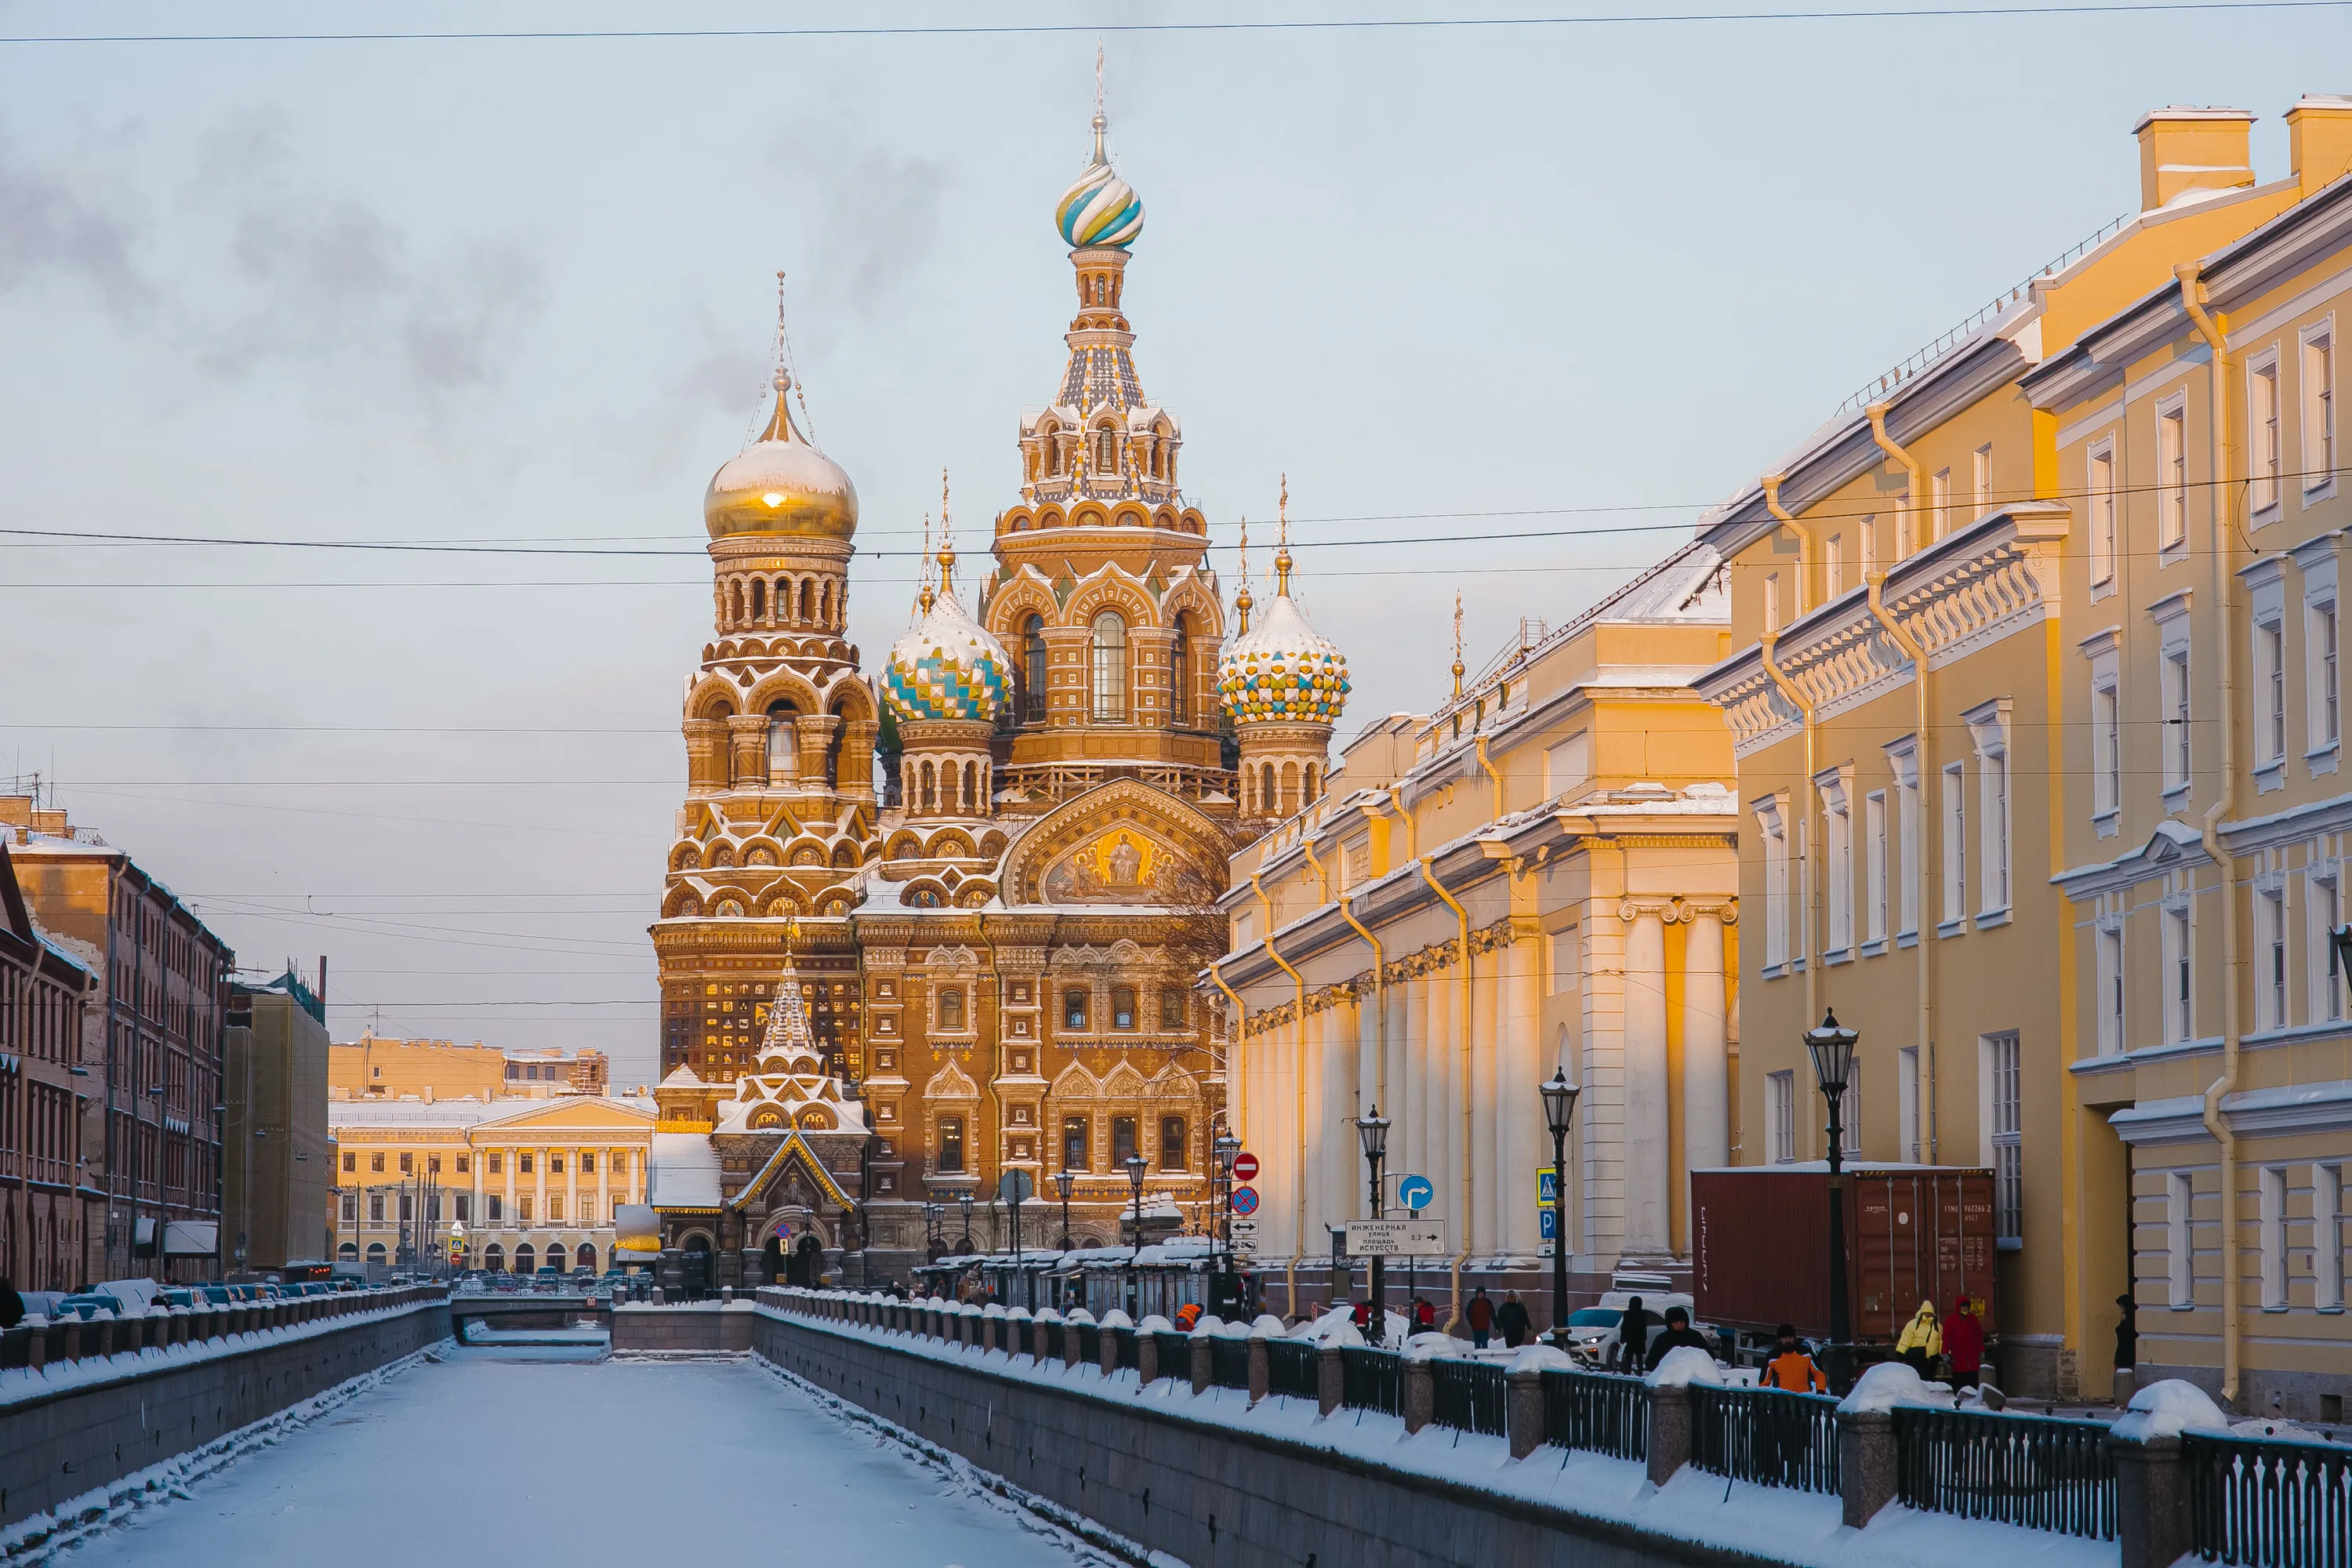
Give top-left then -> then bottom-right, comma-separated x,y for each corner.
2023,99 -> 2352,1420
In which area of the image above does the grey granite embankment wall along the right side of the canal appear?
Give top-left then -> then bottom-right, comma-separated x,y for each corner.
753,1305 -> 1764,1568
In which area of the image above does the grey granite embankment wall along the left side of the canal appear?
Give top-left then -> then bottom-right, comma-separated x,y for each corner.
0,1288 -> 449,1530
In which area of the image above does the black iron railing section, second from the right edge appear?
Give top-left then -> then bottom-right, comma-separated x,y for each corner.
1893,1408 -> 2114,1540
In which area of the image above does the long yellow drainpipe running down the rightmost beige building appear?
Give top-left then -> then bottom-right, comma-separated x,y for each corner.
2173,261 -> 2244,1406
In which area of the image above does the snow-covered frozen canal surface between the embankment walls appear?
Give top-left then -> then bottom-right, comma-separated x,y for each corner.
59,1347 -> 1112,1568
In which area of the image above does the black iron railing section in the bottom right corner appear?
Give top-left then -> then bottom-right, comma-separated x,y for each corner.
2180,1432 -> 2352,1568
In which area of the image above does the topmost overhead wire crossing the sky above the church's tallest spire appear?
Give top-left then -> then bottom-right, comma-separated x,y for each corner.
0,0 -> 2347,45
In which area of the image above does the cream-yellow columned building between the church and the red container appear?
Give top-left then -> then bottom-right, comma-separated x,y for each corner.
1209,543 -> 1740,1316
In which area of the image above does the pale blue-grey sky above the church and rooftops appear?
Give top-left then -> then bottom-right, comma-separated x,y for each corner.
0,0 -> 2352,1083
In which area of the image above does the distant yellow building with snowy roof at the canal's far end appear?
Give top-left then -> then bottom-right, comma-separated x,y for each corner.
327,1095 -> 654,1274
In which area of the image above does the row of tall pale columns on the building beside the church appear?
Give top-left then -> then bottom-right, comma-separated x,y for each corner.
1242,898 -> 1731,1267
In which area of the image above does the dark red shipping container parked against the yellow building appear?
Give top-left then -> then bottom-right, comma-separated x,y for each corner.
1691,1161 -> 1997,1345
